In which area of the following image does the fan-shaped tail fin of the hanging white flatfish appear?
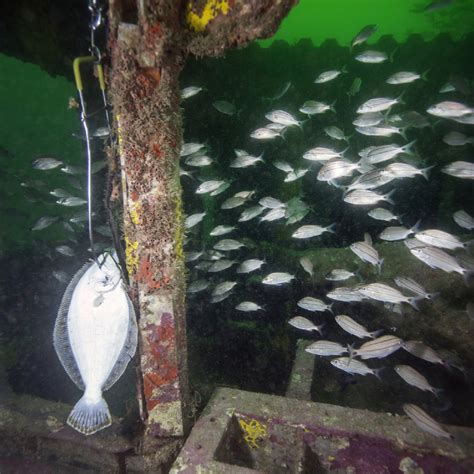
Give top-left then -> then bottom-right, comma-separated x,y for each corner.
67,394 -> 112,436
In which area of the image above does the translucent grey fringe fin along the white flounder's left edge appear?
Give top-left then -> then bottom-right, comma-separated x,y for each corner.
53,262 -> 93,390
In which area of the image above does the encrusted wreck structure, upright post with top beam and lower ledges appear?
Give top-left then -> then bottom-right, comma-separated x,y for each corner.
0,0 -> 474,473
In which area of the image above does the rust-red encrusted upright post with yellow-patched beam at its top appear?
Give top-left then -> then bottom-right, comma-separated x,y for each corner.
108,0 -> 297,464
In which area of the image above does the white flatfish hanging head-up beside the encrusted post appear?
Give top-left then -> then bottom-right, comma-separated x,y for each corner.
54,254 -> 137,435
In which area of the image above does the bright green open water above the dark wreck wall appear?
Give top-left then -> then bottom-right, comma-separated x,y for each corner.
260,0 -> 474,46
